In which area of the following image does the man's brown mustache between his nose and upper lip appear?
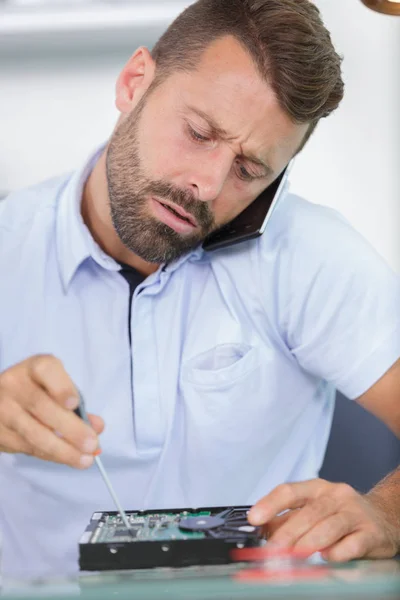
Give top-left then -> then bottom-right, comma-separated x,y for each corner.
144,181 -> 214,228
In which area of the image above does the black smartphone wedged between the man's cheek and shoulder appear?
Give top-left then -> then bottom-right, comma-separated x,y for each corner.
203,160 -> 293,251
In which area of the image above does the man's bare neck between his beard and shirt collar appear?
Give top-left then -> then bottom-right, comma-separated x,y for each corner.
81,149 -> 158,276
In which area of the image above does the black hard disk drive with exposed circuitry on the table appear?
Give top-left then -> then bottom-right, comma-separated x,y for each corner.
79,506 -> 263,571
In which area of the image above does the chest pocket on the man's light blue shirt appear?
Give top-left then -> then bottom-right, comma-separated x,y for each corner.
180,343 -> 272,450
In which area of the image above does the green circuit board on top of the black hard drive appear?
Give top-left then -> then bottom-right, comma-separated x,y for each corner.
90,511 -> 211,544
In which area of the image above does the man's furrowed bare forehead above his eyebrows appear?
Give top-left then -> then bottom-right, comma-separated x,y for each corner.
162,36 -> 307,162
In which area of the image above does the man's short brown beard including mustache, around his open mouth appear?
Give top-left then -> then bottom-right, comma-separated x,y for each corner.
106,91 -> 216,264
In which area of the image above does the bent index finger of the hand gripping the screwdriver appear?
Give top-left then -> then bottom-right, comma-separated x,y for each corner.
28,355 -> 79,409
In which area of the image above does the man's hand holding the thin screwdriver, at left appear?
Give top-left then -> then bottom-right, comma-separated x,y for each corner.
0,355 -> 104,469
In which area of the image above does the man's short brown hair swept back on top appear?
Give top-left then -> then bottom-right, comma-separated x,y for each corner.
152,0 -> 344,150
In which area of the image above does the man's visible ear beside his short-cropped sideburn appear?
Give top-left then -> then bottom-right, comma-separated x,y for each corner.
115,46 -> 155,113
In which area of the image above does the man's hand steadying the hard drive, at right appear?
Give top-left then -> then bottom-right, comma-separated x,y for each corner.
248,479 -> 399,562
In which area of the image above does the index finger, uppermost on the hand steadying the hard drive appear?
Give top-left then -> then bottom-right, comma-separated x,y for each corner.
247,479 -> 333,525
